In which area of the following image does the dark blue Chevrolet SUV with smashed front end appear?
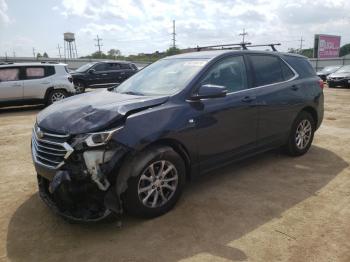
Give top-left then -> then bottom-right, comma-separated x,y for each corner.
32,50 -> 323,222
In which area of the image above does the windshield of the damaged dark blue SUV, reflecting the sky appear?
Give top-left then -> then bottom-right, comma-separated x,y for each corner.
115,58 -> 208,95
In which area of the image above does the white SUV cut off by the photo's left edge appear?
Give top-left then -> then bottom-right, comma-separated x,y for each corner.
0,62 -> 75,106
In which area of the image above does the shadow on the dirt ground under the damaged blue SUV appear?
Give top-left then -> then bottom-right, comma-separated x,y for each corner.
7,146 -> 348,261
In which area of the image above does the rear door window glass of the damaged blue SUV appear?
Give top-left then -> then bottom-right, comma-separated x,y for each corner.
250,55 -> 284,86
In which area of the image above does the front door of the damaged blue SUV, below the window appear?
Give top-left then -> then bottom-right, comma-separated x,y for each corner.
195,90 -> 258,169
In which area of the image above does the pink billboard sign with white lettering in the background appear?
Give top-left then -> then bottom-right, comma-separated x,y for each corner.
317,35 -> 340,58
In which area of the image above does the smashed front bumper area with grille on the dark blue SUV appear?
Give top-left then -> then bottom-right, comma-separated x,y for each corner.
32,128 -> 129,222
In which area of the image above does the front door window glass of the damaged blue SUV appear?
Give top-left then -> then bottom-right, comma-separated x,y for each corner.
201,56 -> 248,93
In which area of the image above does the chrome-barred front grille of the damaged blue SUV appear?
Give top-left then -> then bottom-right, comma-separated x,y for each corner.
32,125 -> 74,169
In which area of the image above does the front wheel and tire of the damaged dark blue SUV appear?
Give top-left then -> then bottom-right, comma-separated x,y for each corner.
123,147 -> 186,218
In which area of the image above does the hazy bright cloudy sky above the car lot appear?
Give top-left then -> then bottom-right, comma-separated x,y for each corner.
0,0 -> 350,57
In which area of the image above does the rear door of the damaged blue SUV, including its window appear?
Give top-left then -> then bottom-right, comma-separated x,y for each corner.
249,54 -> 302,145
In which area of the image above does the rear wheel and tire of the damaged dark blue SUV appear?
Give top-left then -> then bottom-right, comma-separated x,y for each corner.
285,111 -> 316,156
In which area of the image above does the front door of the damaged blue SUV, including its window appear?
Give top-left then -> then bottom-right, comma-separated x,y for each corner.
194,56 -> 258,169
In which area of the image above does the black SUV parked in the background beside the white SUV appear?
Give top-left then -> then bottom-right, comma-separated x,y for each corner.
71,61 -> 138,93
